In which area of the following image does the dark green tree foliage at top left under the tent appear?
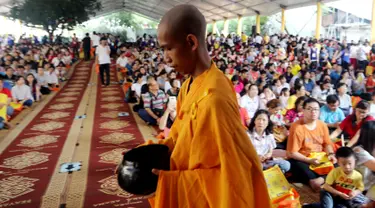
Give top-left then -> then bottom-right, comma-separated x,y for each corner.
9,0 -> 102,37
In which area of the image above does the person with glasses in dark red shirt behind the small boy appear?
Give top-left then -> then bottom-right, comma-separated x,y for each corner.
330,100 -> 375,147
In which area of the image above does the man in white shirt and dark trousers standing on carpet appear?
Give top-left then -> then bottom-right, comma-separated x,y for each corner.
95,37 -> 111,87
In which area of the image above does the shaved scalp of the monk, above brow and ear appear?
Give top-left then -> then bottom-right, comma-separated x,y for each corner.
160,4 -> 206,41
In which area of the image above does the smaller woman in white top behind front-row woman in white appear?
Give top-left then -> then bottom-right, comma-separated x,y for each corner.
241,84 -> 260,118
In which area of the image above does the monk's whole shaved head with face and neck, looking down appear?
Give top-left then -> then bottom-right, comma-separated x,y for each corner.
158,4 -> 211,76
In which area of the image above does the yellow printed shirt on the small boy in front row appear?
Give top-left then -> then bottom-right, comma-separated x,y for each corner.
326,167 -> 365,194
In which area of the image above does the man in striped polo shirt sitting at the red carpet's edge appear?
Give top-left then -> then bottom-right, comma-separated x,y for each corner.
138,80 -> 168,125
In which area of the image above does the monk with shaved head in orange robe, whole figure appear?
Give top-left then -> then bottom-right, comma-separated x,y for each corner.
146,5 -> 271,208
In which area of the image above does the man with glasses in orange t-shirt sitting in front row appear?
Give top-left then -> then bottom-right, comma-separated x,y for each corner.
287,98 -> 337,192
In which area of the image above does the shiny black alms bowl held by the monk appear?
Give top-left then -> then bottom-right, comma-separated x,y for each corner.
117,144 -> 170,195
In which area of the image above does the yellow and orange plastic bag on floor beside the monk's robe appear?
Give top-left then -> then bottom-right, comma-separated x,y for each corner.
263,165 -> 301,208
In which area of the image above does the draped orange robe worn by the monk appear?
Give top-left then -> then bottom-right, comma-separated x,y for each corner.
150,64 -> 270,208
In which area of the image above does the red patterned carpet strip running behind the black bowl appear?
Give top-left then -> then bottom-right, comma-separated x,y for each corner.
84,64 -> 150,208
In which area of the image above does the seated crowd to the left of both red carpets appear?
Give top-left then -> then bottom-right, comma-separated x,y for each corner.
0,35 -> 76,129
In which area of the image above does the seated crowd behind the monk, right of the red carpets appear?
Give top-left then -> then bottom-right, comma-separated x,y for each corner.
121,33 -> 375,207
